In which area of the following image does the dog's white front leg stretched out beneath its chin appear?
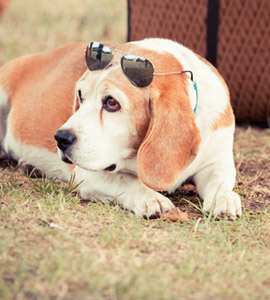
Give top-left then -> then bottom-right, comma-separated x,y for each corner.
75,167 -> 174,217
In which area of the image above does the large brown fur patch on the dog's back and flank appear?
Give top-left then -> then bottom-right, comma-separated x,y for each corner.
0,43 -> 86,152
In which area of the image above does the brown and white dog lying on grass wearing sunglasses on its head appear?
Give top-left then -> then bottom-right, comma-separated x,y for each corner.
0,38 -> 241,217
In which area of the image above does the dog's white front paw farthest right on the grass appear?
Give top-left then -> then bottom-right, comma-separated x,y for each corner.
203,191 -> 242,218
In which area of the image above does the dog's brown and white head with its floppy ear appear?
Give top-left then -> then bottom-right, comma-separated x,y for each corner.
56,40 -> 200,191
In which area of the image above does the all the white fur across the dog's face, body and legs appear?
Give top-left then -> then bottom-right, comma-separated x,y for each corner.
0,39 -> 241,216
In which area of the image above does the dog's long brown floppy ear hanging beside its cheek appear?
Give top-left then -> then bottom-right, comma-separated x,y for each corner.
138,74 -> 200,191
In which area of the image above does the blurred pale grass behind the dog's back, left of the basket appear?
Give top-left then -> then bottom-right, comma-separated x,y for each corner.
0,0 -> 127,66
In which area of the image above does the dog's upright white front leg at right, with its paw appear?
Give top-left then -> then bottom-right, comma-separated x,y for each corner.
169,126 -> 241,216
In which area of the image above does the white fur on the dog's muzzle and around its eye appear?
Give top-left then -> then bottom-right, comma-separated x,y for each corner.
61,69 -> 135,171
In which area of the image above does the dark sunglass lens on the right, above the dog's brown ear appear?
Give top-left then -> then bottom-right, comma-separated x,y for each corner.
121,55 -> 154,87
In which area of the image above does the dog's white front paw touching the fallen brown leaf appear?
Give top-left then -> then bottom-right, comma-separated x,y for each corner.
121,192 -> 174,219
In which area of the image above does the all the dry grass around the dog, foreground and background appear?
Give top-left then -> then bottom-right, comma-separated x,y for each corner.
0,0 -> 270,300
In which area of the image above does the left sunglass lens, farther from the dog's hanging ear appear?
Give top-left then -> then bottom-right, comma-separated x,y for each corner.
85,42 -> 113,71
